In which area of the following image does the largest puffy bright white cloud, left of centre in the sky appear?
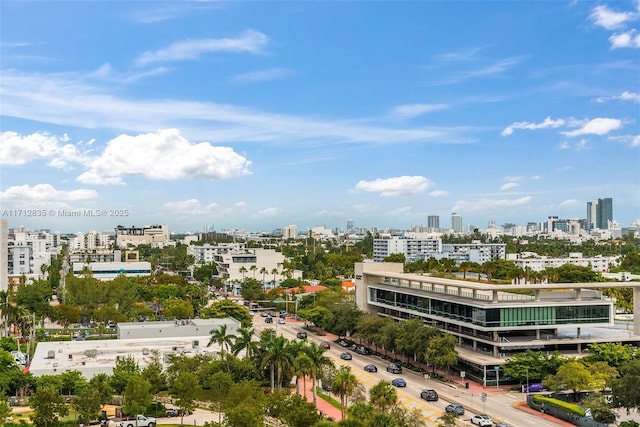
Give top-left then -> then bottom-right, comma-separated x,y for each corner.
78,129 -> 251,184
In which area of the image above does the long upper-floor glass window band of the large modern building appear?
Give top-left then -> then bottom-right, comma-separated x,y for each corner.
369,287 -> 611,328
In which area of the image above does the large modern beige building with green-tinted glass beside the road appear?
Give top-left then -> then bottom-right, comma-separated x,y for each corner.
355,263 -> 640,386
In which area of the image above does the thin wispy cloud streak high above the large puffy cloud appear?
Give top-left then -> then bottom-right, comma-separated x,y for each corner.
136,30 -> 268,66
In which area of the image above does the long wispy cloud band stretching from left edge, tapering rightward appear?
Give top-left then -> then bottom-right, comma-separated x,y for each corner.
0,70 -> 460,146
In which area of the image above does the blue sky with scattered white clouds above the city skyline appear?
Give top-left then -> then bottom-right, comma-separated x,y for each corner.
0,1 -> 640,232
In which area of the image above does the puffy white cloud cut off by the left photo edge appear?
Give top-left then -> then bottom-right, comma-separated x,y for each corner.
0,131 -> 84,169
